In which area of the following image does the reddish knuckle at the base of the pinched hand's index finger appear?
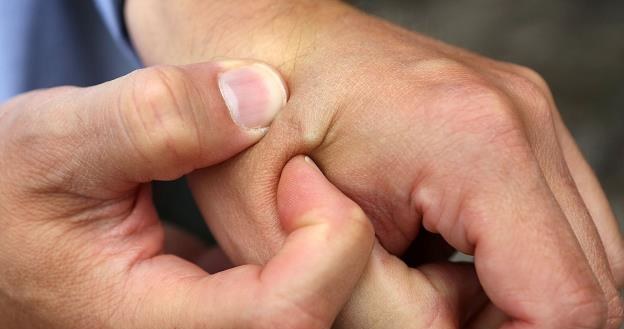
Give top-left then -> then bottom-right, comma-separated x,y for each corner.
432,81 -> 534,182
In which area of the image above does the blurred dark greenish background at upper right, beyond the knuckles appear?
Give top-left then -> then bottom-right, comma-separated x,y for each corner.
350,0 -> 624,231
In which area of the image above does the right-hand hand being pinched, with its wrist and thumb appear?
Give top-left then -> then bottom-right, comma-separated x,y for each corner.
126,0 -> 624,329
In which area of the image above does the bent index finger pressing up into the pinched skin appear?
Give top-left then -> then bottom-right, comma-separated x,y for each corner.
122,156 -> 374,328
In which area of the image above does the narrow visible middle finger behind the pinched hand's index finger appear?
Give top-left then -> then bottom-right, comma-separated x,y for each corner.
490,67 -> 622,328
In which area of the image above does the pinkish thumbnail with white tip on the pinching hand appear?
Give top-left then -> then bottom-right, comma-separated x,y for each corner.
219,62 -> 288,128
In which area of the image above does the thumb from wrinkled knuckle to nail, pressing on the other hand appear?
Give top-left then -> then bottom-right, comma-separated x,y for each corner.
86,61 -> 287,182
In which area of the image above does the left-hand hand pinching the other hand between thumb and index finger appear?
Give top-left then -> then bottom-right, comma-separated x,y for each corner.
0,62 -> 373,329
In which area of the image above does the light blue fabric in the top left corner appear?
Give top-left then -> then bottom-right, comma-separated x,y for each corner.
0,0 -> 140,102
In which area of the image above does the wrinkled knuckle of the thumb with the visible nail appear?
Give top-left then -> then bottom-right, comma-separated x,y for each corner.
119,66 -> 200,170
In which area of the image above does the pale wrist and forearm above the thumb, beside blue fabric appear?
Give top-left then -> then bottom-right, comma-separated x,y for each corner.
126,0 -> 355,75
